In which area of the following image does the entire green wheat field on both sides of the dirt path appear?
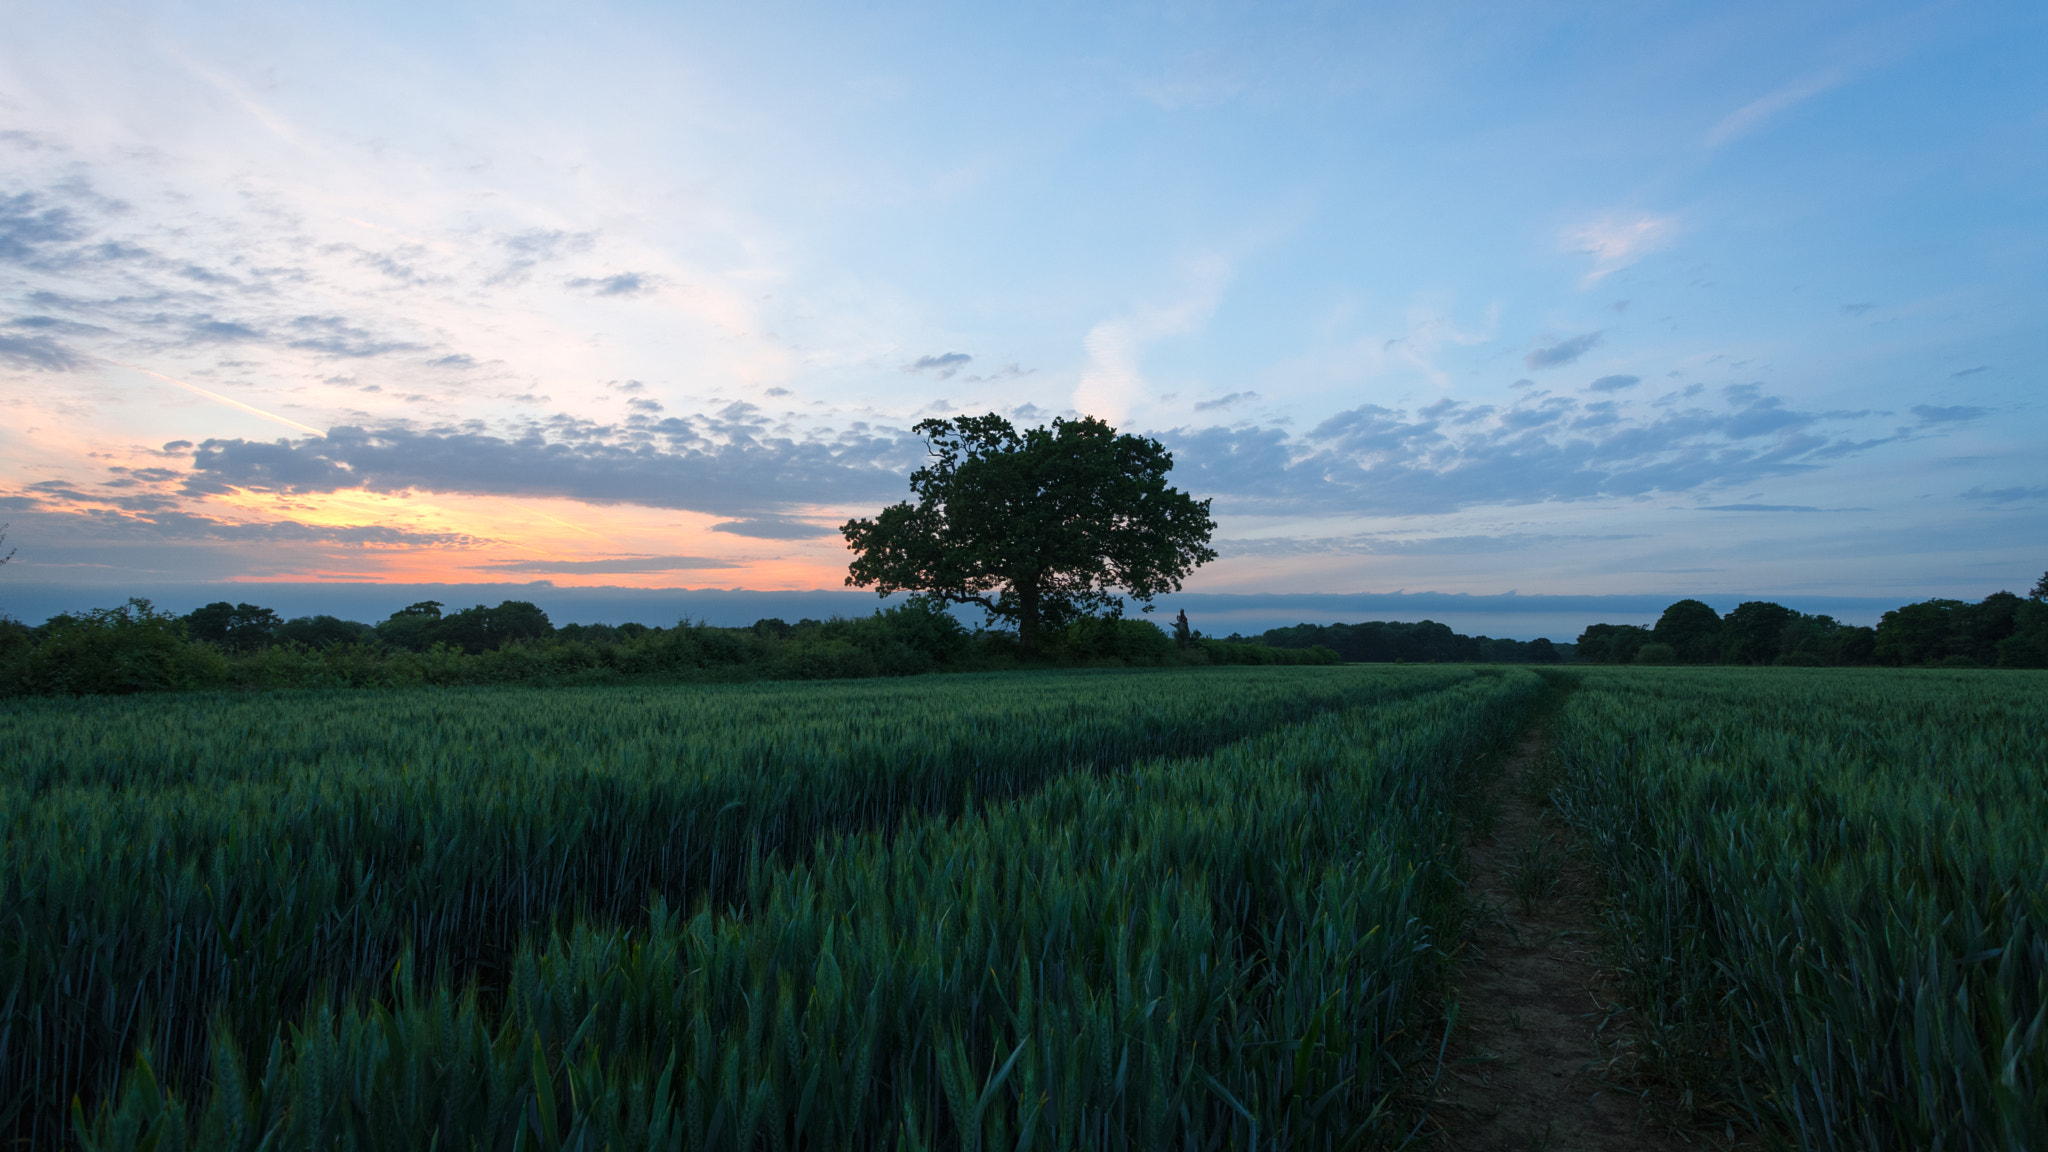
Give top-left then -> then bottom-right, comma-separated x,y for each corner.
0,664 -> 2048,1152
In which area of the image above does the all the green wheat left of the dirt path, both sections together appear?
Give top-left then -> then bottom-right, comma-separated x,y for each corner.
0,668 -> 1534,1148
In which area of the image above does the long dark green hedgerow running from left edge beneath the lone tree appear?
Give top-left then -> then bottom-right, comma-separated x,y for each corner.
0,596 -> 1339,695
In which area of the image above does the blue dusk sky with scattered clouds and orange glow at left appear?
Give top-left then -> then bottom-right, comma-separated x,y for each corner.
0,2 -> 2048,619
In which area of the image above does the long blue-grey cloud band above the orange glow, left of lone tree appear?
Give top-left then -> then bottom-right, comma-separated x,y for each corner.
184,414 -> 920,512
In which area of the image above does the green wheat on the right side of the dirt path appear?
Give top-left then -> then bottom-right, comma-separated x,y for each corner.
1550,668 -> 2048,1152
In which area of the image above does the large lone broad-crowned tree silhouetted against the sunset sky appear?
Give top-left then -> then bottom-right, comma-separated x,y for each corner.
840,412 -> 1217,650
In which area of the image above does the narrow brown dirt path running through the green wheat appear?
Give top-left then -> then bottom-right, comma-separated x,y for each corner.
1432,730 -> 1729,1152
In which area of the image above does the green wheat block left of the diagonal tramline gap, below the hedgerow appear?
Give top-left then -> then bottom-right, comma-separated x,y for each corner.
0,668 -> 1507,1144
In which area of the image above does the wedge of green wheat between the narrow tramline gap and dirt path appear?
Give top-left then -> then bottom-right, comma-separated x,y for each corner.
76,670 -> 1542,1152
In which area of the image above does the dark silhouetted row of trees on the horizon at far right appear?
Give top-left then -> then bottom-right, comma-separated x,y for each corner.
1577,574 -> 2048,668
